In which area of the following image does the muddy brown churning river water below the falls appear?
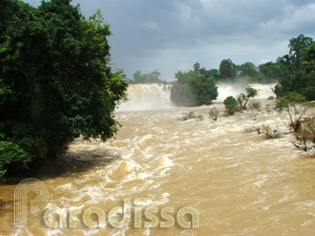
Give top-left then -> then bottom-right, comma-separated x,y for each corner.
0,84 -> 315,236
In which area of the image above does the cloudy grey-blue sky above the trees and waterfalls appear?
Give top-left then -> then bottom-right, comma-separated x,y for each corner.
25,0 -> 315,80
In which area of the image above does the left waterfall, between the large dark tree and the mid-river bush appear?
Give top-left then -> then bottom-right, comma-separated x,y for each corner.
117,84 -> 171,111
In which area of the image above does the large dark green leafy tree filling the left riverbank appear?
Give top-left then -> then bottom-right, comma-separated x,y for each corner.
0,0 -> 127,177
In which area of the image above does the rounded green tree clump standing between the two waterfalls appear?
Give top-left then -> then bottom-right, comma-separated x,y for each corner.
171,64 -> 218,106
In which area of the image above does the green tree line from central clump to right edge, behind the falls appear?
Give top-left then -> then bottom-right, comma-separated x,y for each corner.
171,34 -> 315,106
